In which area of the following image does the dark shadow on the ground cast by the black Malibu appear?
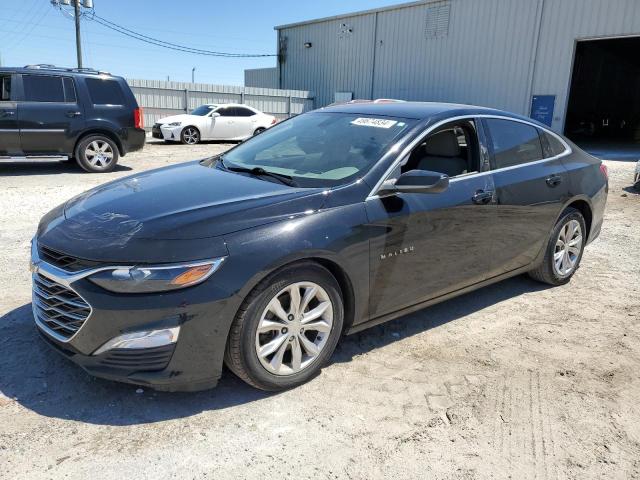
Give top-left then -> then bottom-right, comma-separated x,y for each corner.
0,277 -> 546,426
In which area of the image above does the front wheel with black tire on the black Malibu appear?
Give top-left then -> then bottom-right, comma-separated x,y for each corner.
225,262 -> 344,391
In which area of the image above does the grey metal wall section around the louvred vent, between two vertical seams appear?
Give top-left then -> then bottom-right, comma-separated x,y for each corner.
373,0 -> 537,111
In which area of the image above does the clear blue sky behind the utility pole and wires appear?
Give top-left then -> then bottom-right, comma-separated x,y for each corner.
0,0 -> 401,85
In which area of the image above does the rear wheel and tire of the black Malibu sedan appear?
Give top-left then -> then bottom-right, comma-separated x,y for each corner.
529,207 -> 587,286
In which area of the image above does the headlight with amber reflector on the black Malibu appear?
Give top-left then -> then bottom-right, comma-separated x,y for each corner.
89,257 -> 225,293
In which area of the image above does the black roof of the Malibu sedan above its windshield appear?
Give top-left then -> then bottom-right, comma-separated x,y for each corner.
319,102 -> 538,124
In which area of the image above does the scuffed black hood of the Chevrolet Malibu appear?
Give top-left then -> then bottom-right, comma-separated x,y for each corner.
38,162 -> 326,260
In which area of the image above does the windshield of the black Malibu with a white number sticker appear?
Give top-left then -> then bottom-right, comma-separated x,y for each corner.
214,112 -> 415,187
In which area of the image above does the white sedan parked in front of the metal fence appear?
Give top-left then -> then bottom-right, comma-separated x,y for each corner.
152,103 -> 278,145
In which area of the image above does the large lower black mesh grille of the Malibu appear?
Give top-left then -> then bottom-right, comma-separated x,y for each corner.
33,273 -> 91,339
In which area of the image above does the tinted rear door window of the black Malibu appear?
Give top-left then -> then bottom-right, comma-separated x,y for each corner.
485,118 -> 544,169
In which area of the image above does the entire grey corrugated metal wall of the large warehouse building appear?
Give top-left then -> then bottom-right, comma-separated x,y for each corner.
279,0 -> 640,130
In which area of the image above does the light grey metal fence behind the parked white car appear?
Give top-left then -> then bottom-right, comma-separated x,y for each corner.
127,79 -> 314,128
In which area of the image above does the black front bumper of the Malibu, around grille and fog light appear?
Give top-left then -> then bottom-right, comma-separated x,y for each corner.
31,240 -> 241,391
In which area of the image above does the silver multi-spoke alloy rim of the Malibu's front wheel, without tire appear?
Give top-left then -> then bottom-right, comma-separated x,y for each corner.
255,282 -> 333,375
